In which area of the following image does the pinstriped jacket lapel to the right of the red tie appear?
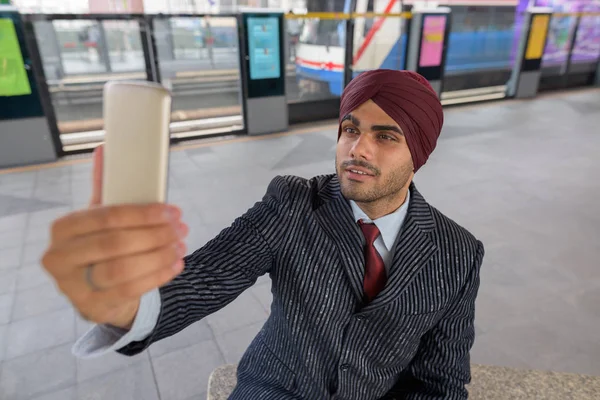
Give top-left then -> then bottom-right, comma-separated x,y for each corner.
363,184 -> 437,311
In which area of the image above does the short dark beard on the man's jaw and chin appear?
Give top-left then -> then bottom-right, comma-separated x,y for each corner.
335,159 -> 413,203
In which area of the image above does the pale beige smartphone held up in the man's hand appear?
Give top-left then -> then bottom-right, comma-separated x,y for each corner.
102,81 -> 171,205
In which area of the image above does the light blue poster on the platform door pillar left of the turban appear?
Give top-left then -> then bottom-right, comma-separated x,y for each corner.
248,17 -> 281,79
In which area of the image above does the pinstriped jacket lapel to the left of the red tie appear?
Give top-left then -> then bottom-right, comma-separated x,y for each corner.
315,176 -> 364,300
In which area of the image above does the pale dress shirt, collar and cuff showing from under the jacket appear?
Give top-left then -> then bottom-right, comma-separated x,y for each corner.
72,192 -> 410,358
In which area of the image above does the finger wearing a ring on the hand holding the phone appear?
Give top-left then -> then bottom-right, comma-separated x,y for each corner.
86,242 -> 186,290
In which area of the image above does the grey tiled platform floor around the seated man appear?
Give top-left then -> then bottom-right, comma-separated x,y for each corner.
0,90 -> 600,400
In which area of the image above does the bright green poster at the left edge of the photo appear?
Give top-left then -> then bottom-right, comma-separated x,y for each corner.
0,18 -> 31,96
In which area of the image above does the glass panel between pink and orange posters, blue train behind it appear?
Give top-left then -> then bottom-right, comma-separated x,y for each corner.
444,6 -> 515,91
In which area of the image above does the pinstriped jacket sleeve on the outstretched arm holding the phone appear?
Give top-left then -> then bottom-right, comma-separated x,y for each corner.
117,177 -> 289,356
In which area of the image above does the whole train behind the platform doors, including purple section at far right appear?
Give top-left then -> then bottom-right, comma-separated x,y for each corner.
295,0 -> 600,96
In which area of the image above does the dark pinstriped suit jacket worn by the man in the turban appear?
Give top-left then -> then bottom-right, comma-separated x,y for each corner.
119,175 -> 484,400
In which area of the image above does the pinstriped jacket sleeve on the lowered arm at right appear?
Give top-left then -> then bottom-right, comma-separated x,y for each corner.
384,241 -> 484,400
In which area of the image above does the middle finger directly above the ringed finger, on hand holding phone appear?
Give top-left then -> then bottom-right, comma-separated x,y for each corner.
44,223 -> 189,278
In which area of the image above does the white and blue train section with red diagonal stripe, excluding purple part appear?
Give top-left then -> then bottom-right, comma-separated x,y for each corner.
296,0 -> 517,96
